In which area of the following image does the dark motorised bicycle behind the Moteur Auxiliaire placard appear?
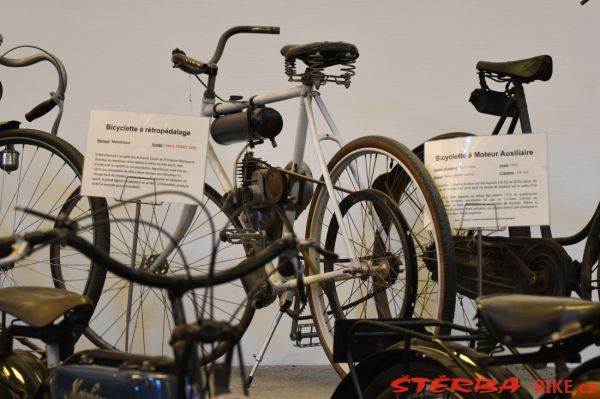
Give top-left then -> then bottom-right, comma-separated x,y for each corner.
406,55 -> 600,325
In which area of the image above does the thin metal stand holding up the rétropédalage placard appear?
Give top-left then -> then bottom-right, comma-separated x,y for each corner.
115,176 -> 162,352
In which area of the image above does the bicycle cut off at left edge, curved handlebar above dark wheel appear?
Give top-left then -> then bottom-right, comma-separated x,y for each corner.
0,36 -> 110,328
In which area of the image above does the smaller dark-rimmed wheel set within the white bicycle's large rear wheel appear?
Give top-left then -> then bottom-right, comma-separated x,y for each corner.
323,189 -> 417,319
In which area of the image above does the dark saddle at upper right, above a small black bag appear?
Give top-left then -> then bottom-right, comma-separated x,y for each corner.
477,55 -> 552,83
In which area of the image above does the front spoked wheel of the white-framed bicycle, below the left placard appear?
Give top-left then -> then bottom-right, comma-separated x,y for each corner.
86,185 -> 254,360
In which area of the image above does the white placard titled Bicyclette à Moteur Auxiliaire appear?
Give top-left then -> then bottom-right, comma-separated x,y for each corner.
425,134 -> 550,228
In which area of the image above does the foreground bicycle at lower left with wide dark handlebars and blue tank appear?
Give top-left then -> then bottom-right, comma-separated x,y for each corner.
0,204 -> 304,399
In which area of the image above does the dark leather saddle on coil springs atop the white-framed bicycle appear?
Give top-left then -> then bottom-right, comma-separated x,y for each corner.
281,42 -> 358,68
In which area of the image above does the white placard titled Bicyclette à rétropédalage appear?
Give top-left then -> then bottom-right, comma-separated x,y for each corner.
82,110 -> 208,204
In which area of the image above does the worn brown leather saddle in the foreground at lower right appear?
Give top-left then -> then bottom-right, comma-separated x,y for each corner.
476,295 -> 600,346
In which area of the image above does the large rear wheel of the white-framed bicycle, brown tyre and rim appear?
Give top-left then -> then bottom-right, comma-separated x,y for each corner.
307,136 -> 456,374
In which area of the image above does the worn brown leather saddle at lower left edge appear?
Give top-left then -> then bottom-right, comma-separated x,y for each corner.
0,287 -> 94,327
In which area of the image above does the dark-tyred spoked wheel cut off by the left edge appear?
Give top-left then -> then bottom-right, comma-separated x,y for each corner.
0,129 -> 109,301
